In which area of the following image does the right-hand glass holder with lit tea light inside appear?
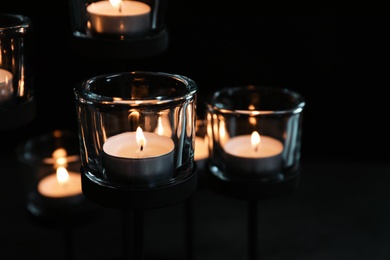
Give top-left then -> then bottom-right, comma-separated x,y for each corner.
207,85 -> 305,183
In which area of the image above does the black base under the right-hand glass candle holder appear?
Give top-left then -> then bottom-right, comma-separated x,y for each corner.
205,164 -> 301,201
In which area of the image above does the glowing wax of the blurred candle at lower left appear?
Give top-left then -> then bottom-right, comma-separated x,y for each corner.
38,172 -> 82,198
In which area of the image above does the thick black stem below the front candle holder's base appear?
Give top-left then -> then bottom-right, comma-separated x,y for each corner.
122,210 -> 144,260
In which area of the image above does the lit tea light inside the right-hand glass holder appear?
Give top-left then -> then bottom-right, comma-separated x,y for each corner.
223,131 -> 283,175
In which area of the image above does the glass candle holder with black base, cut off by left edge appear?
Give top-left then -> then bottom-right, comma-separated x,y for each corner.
0,13 -> 35,129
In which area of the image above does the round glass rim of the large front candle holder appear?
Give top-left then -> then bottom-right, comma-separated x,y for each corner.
74,71 -> 197,104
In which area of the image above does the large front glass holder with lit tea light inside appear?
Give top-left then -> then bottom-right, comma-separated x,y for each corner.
74,71 -> 197,189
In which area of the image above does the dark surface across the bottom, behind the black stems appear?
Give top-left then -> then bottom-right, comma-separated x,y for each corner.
0,157 -> 390,260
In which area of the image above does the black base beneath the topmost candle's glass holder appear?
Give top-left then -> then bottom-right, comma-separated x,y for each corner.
71,30 -> 169,59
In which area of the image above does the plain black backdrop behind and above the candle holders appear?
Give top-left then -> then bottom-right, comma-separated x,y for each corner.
0,3 -> 389,162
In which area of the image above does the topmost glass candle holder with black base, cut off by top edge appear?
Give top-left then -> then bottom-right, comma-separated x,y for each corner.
70,0 -> 168,59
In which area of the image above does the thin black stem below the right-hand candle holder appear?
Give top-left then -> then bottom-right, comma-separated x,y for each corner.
248,200 -> 258,260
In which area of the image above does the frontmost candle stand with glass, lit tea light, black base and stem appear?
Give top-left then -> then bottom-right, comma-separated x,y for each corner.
74,71 -> 197,260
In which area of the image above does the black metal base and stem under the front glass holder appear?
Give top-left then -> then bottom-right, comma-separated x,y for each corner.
81,165 -> 197,260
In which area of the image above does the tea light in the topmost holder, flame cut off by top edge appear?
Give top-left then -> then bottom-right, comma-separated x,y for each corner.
87,1 -> 151,35
